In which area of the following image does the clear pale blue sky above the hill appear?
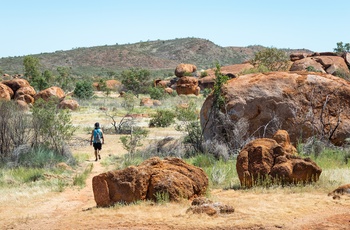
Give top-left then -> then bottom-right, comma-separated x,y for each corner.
0,0 -> 350,57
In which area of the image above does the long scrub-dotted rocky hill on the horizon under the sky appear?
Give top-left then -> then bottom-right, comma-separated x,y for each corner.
0,38 -> 311,76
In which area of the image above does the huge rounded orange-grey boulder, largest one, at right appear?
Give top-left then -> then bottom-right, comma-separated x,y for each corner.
200,72 -> 350,145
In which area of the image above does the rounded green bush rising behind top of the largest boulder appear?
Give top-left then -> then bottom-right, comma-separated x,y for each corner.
252,48 -> 289,71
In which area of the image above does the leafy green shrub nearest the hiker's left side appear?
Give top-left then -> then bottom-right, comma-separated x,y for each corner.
32,99 -> 75,155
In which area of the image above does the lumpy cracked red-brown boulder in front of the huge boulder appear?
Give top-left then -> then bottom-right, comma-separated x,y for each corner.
236,131 -> 322,187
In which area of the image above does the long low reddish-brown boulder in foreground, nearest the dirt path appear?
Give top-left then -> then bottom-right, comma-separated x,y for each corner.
92,157 -> 208,207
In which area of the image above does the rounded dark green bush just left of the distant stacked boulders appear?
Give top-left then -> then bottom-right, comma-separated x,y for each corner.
121,68 -> 151,97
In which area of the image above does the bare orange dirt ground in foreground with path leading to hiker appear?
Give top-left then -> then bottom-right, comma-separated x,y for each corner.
0,132 -> 350,230
